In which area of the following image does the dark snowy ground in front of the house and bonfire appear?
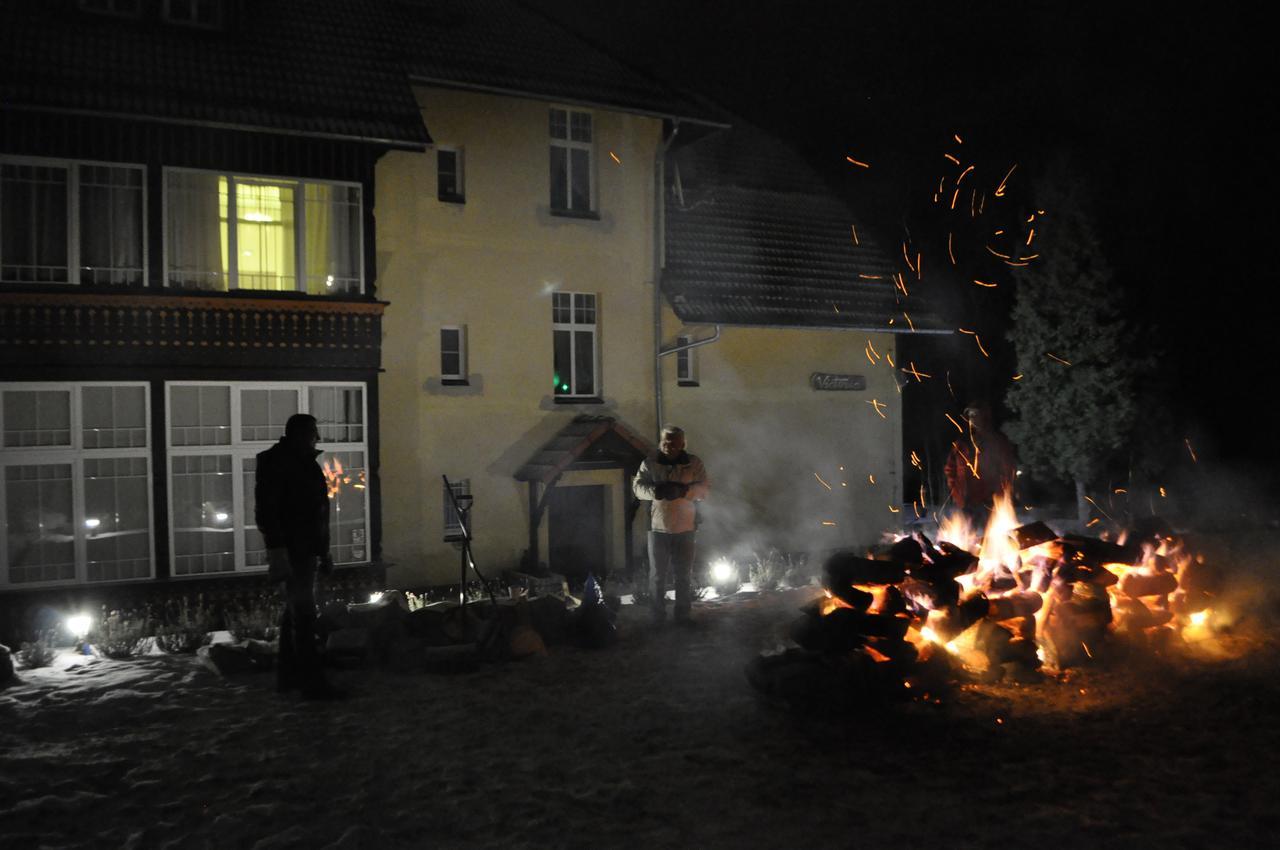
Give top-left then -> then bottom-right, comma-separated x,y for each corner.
0,540 -> 1280,849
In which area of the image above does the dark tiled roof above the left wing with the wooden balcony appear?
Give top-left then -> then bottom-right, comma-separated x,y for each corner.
0,0 -> 430,147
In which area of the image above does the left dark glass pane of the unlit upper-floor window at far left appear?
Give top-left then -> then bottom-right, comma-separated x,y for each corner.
0,163 -> 68,283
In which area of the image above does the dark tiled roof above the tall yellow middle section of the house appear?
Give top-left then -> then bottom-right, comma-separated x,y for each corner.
383,0 -> 721,123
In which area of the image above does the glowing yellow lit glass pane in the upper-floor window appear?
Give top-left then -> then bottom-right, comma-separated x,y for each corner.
236,178 -> 294,292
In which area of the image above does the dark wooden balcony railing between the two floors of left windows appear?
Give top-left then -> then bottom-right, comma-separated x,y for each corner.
0,291 -> 387,369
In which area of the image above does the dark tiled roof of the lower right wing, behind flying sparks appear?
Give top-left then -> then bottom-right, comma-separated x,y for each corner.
662,123 -> 943,333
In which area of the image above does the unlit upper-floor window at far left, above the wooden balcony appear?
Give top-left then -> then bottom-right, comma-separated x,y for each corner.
0,159 -> 146,287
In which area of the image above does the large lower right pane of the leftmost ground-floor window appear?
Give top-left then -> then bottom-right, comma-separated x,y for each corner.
84,457 -> 151,581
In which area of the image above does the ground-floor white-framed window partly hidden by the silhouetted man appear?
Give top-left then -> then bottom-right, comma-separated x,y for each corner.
166,381 -> 370,576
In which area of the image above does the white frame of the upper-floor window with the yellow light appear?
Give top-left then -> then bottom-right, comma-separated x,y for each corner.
160,165 -> 366,296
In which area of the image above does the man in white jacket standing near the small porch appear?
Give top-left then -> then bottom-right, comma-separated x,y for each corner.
631,425 -> 712,622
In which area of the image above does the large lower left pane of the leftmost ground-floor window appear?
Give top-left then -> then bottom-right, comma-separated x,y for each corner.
4,463 -> 76,584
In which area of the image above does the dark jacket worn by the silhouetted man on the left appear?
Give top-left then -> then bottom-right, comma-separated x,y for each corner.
253,437 -> 329,559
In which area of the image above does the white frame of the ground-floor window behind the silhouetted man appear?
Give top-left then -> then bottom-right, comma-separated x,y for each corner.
164,380 -> 372,579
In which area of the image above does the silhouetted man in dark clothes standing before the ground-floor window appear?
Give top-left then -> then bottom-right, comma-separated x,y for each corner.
253,413 -> 340,699
